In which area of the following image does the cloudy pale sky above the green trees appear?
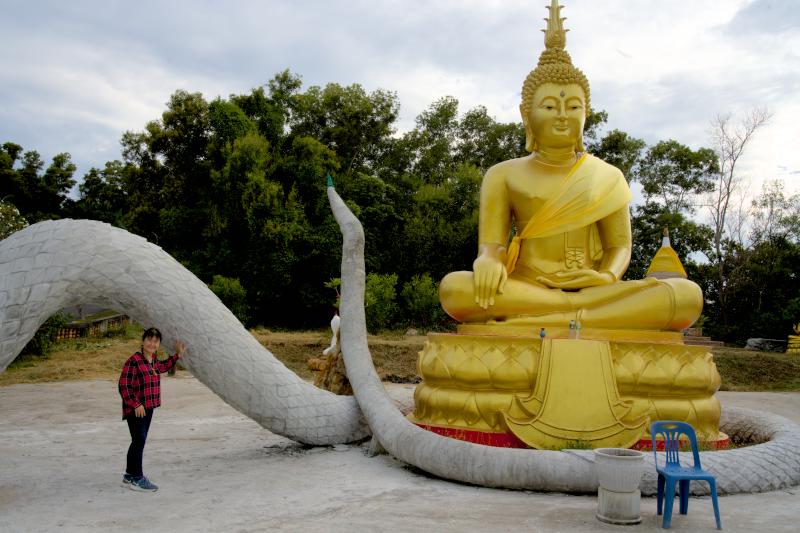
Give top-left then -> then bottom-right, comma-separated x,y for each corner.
0,0 -> 800,206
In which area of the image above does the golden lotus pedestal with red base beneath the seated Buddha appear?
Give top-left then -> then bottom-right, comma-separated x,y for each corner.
409,324 -> 728,449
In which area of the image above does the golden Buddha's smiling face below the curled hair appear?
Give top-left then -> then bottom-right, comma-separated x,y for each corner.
522,83 -> 586,149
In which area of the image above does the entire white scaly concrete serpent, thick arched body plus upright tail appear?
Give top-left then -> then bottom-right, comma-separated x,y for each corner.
0,187 -> 800,494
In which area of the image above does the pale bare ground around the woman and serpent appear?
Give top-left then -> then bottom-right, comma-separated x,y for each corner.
0,377 -> 800,533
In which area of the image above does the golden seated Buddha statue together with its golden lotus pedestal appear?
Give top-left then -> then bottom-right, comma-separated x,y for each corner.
409,0 -> 727,448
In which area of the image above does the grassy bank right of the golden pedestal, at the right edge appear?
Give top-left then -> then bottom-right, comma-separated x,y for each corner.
712,347 -> 800,391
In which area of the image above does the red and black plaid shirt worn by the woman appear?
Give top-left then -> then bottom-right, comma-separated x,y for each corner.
119,352 -> 178,418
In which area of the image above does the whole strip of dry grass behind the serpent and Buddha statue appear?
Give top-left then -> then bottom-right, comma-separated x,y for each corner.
0,328 -> 800,391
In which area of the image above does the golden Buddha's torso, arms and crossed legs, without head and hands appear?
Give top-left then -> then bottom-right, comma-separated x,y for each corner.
440,154 -> 702,331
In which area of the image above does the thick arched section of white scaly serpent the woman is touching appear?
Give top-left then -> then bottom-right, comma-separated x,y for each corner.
0,220 -> 369,444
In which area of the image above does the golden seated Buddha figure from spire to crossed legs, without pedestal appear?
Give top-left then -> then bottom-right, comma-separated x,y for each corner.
440,2 -> 703,331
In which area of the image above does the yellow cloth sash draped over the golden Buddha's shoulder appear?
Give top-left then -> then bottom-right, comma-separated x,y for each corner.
506,152 -> 631,274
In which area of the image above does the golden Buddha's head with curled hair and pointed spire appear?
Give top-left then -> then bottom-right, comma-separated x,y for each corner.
519,0 -> 589,152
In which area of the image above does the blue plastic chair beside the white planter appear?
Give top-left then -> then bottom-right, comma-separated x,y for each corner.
650,420 -> 722,529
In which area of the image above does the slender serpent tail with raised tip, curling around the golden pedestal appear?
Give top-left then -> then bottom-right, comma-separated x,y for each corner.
328,187 -> 800,494
